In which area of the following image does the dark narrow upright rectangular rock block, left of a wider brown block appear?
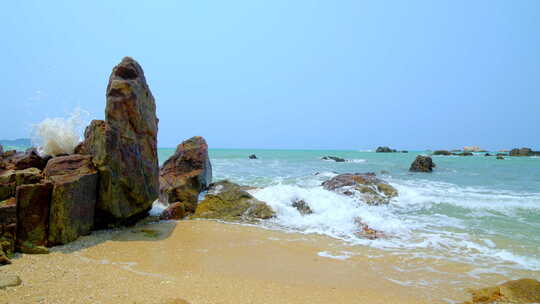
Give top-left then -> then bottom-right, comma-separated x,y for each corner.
16,182 -> 53,252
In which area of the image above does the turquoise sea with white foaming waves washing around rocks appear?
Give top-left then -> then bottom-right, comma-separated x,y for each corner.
159,149 -> 540,278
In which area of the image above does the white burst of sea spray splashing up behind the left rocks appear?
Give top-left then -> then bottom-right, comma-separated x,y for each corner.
33,108 -> 89,156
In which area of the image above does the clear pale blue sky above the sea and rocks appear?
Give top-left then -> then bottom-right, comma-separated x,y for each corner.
0,0 -> 540,150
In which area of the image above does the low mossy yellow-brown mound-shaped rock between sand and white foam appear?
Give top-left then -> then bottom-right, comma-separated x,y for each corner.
193,181 -> 275,221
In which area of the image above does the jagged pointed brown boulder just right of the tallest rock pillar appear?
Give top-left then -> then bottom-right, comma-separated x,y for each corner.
159,136 -> 212,213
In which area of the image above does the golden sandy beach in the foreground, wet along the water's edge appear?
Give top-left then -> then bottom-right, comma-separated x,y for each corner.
0,220 -> 528,304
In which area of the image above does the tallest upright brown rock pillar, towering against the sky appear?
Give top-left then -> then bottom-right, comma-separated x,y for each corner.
76,57 -> 159,227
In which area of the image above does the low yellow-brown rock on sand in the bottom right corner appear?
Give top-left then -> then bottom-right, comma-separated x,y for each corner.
464,279 -> 540,304
